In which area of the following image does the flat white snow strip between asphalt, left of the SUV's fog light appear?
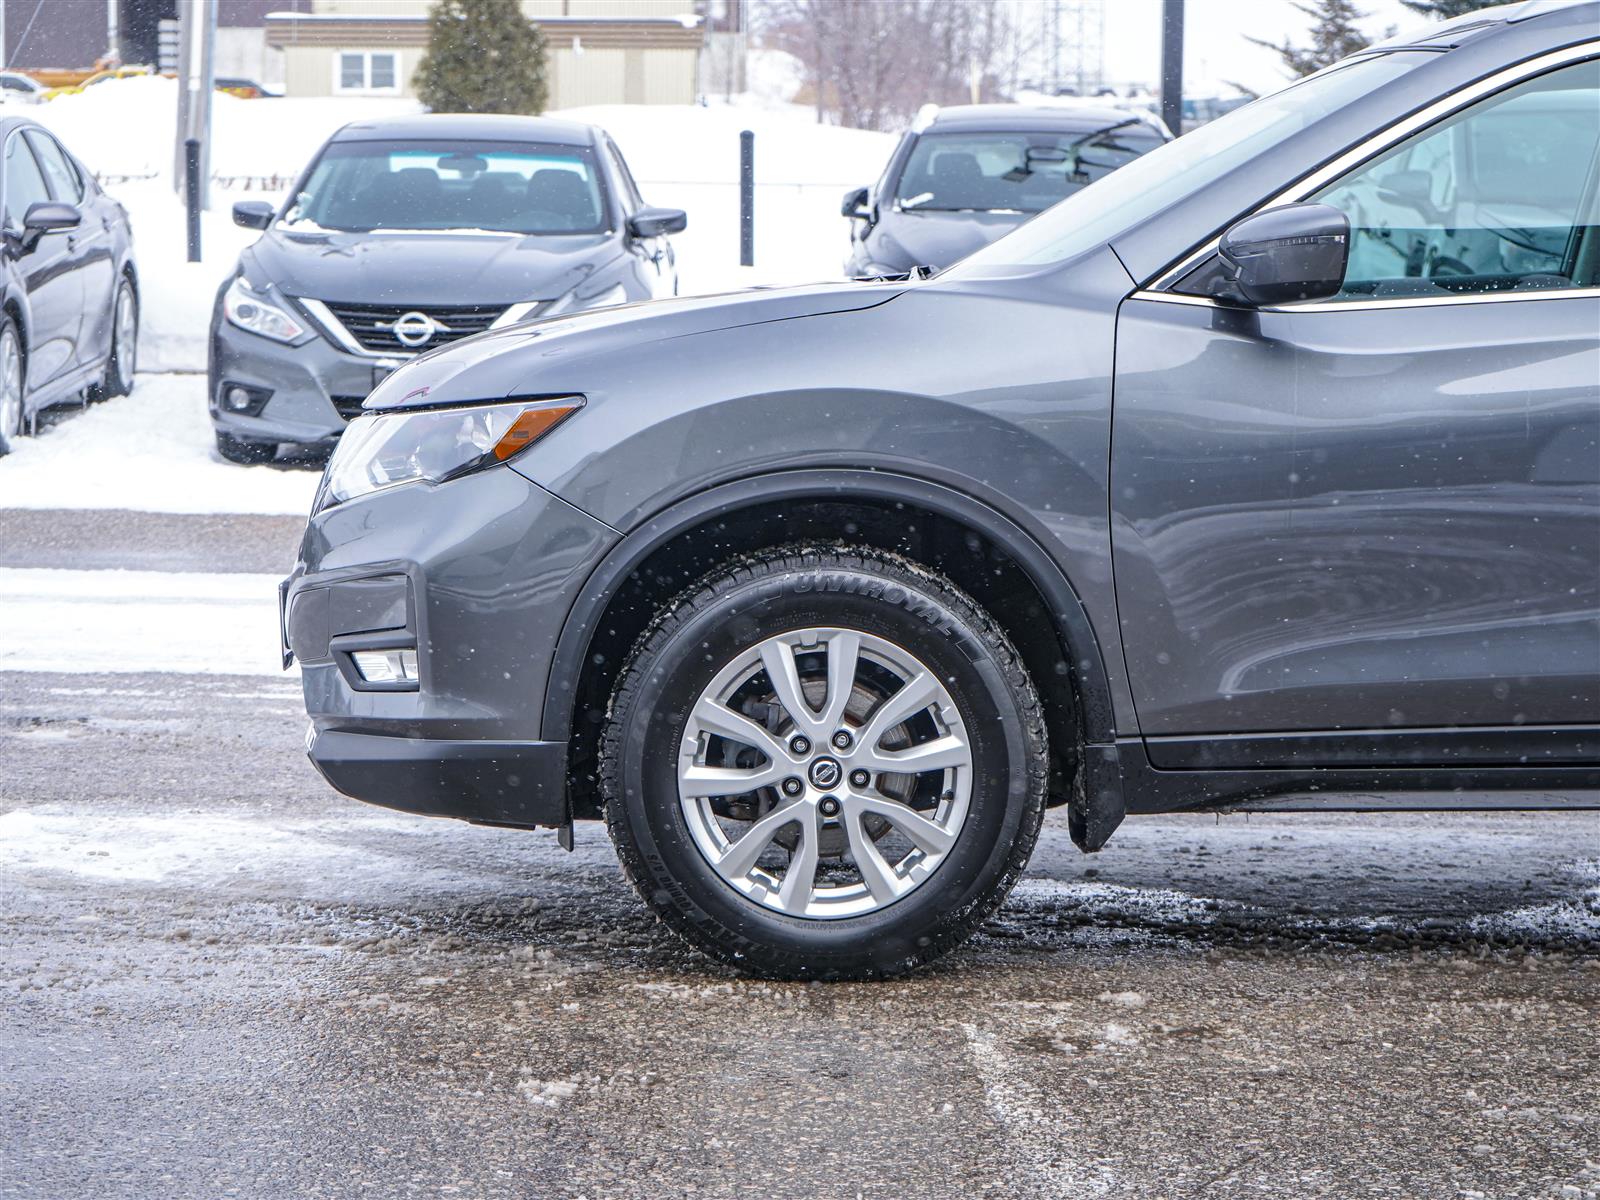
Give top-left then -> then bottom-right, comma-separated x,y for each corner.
0,568 -> 283,675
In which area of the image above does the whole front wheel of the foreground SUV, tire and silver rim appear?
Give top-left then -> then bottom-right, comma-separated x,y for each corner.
602,547 -> 1046,978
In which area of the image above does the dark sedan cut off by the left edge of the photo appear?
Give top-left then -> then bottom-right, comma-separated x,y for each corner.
0,117 -> 139,453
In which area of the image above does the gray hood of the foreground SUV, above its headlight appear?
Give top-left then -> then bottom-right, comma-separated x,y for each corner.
365,283 -> 906,410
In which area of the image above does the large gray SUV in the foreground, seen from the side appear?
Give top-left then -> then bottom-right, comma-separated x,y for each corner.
285,0 -> 1600,976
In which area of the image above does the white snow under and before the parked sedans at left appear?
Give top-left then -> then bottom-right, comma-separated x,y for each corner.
0,374 -> 318,515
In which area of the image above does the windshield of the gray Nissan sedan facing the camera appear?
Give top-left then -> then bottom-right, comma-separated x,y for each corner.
283,141 -> 606,234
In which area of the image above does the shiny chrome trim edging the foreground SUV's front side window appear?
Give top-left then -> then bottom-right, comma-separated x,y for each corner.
1141,42 -> 1600,296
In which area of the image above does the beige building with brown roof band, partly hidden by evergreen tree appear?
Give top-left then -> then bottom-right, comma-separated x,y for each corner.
266,0 -> 706,109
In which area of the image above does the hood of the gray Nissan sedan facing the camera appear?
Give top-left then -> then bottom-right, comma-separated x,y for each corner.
240,229 -> 619,306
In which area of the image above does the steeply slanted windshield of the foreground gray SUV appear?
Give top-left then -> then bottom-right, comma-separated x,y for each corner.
946,53 -> 1426,278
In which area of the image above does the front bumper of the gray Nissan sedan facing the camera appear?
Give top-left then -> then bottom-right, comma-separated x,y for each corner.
206,320 -> 406,446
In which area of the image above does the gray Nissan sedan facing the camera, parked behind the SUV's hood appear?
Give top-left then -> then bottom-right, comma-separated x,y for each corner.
210,115 -> 686,462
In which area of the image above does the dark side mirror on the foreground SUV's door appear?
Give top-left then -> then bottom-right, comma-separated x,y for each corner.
1218,205 -> 1350,306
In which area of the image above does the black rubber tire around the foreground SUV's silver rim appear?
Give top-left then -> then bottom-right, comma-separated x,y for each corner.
600,546 -> 1046,979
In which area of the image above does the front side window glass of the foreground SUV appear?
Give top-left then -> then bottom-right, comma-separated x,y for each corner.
1310,62 -> 1600,299
